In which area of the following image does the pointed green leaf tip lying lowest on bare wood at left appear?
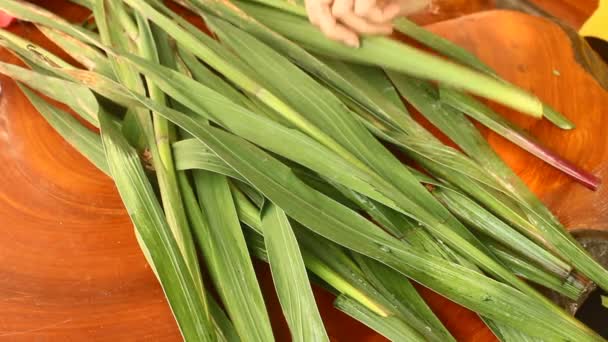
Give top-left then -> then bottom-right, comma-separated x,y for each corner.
17,83 -> 110,175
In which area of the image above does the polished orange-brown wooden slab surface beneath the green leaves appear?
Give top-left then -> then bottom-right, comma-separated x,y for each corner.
0,1 -> 608,341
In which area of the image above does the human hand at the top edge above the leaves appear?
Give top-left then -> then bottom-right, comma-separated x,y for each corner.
306,0 -> 431,47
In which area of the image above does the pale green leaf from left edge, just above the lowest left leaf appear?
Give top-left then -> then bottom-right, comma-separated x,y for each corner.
0,62 -> 99,126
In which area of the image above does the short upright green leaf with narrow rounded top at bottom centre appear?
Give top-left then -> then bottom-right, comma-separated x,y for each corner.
262,204 -> 329,341
